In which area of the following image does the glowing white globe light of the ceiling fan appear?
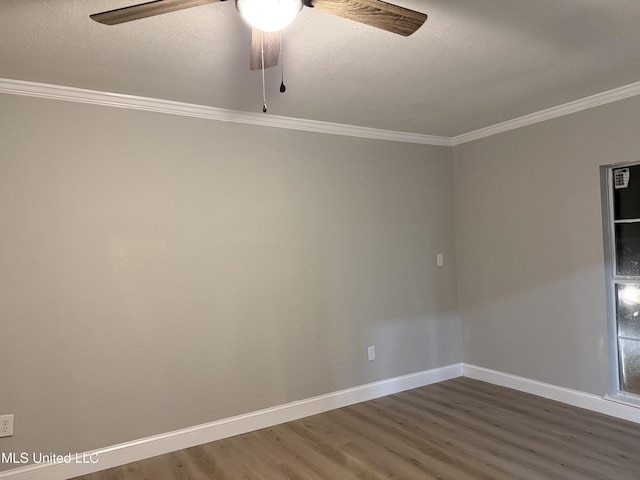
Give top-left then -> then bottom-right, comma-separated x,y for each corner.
236,0 -> 302,32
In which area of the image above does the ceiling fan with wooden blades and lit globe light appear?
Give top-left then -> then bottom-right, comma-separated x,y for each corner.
91,0 -> 427,70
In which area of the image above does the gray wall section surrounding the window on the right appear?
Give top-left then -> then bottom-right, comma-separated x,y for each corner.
454,97 -> 640,395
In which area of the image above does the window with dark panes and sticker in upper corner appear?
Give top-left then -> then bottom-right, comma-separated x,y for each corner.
602,164 -> 640,400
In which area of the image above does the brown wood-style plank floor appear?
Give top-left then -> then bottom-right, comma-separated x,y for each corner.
72,378 -> 640,480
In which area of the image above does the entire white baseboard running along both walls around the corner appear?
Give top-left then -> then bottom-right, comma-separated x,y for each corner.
6,363 -> 640,480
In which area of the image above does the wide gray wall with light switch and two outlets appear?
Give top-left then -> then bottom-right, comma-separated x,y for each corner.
0,95 -> 460,468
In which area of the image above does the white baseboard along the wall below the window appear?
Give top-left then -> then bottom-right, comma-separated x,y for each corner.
464,363 -> 640,423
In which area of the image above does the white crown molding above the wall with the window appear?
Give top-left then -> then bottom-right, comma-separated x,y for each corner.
450,82 -> 640,146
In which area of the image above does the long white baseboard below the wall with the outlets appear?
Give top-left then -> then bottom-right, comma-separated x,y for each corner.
0,363 -> 463,480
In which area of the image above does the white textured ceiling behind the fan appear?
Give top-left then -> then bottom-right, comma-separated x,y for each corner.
0,0 -> 640,137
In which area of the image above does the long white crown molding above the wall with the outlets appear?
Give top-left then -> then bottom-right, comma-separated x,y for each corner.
0,79 -> 451,147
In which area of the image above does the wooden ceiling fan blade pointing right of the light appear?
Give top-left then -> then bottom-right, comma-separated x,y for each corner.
310,0 -> 427,37
